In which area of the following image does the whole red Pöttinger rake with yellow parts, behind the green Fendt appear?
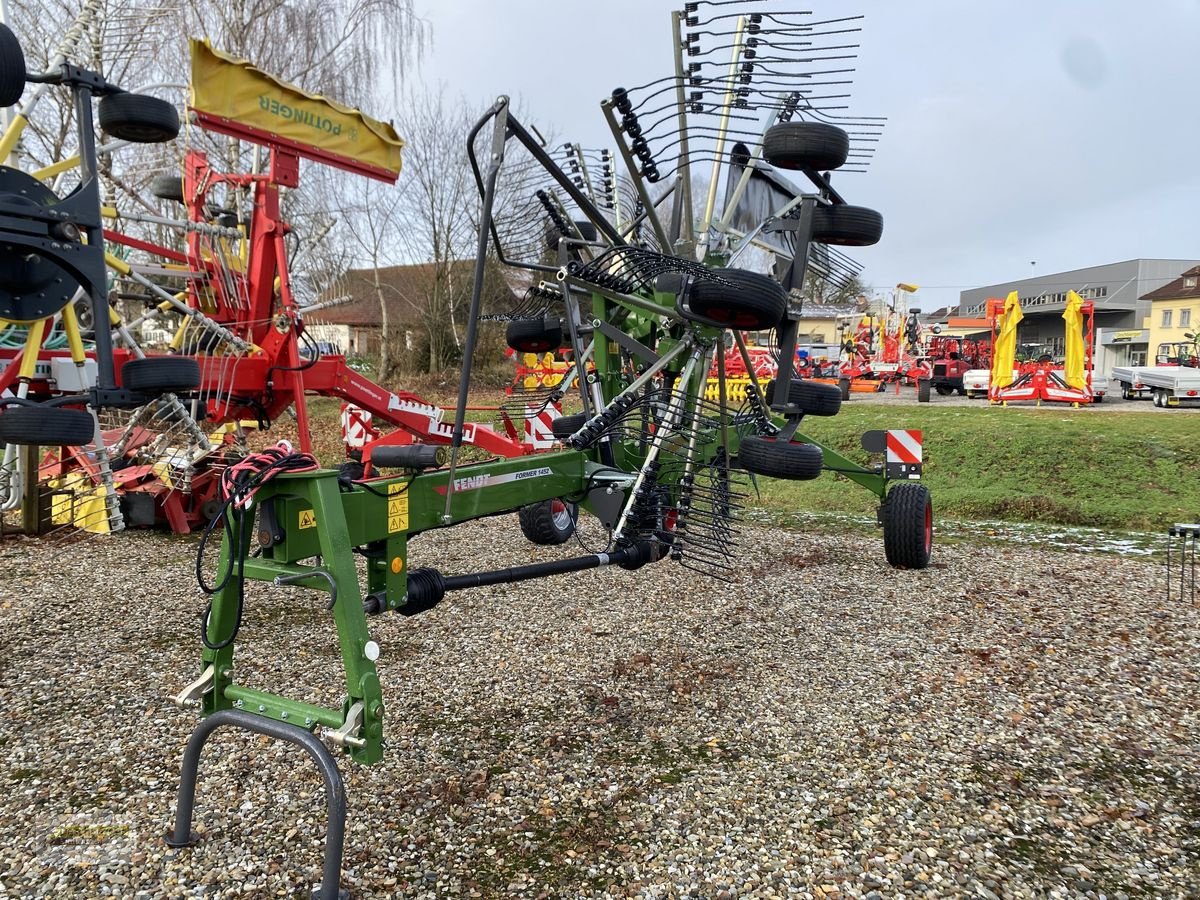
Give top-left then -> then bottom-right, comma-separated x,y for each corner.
0,42 -> 542,533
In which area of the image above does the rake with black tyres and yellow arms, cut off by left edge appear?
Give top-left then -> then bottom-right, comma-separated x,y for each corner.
0,19 -> 198,529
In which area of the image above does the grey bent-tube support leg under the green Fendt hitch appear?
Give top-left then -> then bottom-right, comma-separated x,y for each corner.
164,709 -> 350,900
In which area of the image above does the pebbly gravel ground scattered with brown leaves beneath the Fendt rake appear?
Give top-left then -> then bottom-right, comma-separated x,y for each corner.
0,517 -> 1200,899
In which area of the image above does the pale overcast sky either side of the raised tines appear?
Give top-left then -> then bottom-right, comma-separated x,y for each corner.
416,0 -> 1200,311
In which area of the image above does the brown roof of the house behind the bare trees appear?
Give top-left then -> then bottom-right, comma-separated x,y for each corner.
311,259 -> 524,328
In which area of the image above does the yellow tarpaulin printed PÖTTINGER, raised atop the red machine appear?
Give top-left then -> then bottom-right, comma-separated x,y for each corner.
191,38 -> 404,182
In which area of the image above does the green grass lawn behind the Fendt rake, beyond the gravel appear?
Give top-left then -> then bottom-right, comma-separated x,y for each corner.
292,384 -> 1200,530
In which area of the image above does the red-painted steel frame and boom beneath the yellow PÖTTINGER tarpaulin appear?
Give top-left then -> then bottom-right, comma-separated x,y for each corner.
0,136 -> 534,533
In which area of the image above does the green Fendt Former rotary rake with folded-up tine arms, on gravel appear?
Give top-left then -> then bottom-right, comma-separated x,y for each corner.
5,2 -> 932,900
